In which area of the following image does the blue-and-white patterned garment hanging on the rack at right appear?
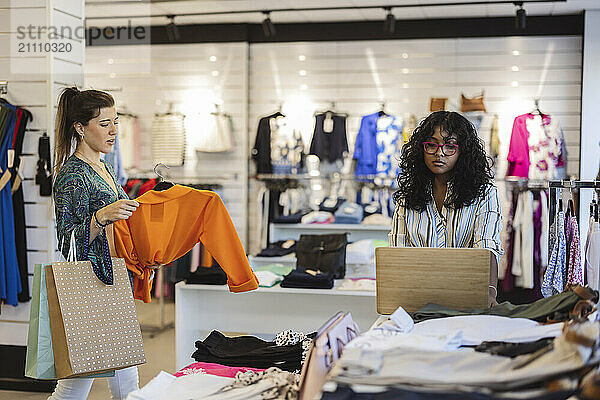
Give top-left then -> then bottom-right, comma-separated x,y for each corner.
542,211 -> 567,297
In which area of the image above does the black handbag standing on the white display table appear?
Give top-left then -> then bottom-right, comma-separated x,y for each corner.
296,233 -> 348,279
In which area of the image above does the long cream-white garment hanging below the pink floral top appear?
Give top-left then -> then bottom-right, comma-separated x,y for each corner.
512,191 -> 534,289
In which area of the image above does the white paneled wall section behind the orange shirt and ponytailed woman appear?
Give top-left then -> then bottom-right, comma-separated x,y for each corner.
85,43 -> 248,244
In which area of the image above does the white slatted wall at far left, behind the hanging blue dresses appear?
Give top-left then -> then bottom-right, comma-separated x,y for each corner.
0,0 -> 85,346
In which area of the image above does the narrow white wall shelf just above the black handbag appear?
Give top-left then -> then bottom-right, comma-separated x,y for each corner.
269,224 -> 391,242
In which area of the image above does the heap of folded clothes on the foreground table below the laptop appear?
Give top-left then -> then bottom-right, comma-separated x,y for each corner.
322,286 -> 600,400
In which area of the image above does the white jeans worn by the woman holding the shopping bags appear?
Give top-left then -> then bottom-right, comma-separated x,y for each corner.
48,367 -> 139,400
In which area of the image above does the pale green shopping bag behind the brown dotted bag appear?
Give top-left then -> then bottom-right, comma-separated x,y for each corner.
25,264 -> 115,380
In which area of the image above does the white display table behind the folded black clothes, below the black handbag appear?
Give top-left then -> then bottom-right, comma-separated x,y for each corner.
175,280 -> 377,369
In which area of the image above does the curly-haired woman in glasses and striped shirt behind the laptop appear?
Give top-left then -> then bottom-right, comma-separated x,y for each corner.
389,111 -> 503,305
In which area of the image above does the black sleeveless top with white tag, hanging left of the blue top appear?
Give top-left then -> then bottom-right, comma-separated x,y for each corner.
309,113 -> 348,163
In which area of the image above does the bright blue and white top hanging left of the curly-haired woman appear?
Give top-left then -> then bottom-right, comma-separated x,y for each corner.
353,112 -> 403,179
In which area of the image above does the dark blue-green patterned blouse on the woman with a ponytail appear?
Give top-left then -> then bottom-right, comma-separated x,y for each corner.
53,155 -> 128,285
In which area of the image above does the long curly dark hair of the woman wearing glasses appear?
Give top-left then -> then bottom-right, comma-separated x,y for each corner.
394,111 -> 493,211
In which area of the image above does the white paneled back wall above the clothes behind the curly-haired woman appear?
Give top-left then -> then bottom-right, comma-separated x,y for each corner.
249,36 -> 582,252
